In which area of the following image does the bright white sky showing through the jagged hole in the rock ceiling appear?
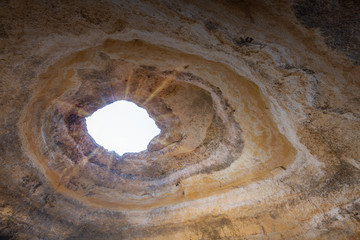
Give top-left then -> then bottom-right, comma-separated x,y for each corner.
86,101 -> 160,155
